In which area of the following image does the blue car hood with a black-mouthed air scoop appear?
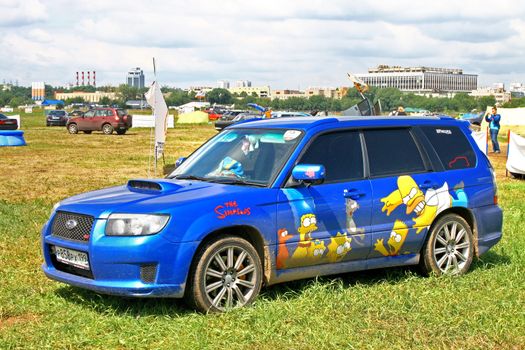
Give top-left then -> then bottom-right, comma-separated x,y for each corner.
57,179 -> 253,219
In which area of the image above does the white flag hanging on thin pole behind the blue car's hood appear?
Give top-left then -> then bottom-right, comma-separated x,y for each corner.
145,81 -> 168,159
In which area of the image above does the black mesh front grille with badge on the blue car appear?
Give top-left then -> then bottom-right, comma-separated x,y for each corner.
51,211 -> 95,242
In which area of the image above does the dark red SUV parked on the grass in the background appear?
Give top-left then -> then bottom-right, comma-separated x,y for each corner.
66,108 -> 132,135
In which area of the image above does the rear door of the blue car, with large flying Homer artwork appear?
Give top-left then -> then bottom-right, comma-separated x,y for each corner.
363,128 -> 436,258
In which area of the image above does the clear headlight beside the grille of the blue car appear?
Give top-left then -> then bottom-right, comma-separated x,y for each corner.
106,214 -> 170,236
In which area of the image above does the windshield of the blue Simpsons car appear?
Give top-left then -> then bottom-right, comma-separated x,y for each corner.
168,129 -> 302,186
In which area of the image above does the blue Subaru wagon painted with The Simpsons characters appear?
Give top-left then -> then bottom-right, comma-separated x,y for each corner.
41,116 -> 503,312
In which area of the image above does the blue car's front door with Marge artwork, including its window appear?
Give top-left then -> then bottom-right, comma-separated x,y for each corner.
276,131 -> 372,269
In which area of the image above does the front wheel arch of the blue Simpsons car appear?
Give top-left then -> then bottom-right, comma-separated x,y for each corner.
190,225 -> 272,284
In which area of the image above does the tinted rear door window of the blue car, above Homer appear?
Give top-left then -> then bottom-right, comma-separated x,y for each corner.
364,129 -> 426,177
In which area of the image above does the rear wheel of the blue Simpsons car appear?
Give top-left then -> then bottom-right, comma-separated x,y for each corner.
419,214 -> 474,276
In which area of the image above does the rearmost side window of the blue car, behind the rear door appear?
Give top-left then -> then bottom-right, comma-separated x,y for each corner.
421,126 -> 476,170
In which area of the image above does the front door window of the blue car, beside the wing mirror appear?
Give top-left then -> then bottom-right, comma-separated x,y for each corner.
299,131 -> 363,183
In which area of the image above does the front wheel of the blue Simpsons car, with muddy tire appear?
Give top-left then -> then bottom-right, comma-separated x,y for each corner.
185,236 -> 262,312
